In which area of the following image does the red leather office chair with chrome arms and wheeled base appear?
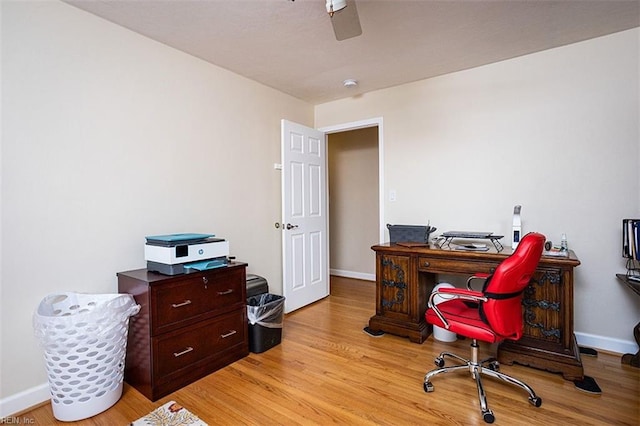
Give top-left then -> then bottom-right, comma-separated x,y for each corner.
424,233 -> 545,423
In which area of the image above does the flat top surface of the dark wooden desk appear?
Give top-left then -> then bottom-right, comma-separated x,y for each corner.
371,243 -> 580,266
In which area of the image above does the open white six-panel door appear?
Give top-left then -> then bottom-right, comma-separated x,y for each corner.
282,120 -> 329,312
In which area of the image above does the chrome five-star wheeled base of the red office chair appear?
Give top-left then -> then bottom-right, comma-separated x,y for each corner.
424,339 -> 542,423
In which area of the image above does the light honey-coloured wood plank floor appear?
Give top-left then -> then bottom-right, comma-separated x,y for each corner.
19,277 -> 640,426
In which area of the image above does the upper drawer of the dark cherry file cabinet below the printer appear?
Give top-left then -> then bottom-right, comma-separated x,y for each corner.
151,269 -> 246,335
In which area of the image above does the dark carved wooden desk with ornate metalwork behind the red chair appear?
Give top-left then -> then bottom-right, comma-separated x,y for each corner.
369,243 -> 584,380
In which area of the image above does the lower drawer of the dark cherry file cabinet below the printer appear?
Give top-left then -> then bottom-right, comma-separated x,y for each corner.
153,310 -> 247,378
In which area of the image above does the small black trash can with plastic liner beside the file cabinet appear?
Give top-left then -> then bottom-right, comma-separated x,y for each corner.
247,293 -> 284,354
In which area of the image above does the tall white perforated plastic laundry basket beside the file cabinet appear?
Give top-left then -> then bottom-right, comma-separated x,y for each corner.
33,293 -> 140,421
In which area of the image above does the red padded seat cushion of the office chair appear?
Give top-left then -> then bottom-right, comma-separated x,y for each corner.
426,299 -> 503,343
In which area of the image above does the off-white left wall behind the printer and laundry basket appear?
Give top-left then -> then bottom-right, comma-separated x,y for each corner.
0,1 -> 313,416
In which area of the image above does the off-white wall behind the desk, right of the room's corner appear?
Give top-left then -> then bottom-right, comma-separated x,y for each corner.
315,29 -> 640,352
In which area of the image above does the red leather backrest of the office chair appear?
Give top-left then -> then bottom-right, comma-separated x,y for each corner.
480,232 -> 546,340
